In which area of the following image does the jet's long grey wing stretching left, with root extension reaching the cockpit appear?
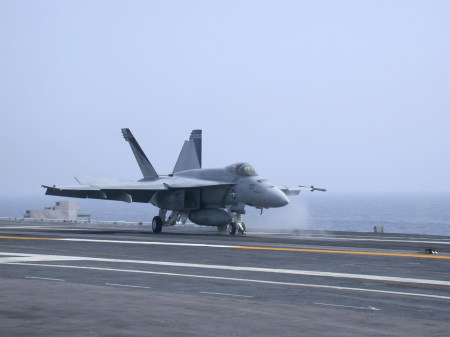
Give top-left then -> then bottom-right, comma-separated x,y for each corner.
42,177 -> 233,203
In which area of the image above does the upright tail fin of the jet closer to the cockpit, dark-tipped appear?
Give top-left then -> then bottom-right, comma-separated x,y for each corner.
173,130 -> 202,173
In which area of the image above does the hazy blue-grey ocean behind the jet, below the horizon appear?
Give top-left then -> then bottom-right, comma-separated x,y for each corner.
0,192 -> 450,235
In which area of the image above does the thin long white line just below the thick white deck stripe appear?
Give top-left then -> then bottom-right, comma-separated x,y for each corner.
15,263 -> 450,301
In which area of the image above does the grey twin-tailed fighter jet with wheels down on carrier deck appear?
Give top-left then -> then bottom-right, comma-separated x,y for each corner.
42,129 -> 326,235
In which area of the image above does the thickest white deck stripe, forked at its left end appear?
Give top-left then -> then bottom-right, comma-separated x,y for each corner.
0,253 -> 450,287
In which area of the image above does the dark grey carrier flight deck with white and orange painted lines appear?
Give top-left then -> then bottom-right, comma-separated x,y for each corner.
0,222 -> 450,336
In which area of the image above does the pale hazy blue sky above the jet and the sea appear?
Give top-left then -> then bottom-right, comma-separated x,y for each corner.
0,0 -> 450,196
